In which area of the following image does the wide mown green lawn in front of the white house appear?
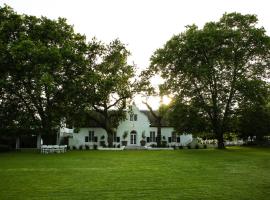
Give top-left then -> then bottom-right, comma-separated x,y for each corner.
0,147 -> 270,200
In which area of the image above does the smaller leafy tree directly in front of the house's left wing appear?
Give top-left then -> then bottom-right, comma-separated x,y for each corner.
72,40 -> 136,147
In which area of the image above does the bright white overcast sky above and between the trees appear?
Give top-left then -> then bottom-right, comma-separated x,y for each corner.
0,0 -> 270,107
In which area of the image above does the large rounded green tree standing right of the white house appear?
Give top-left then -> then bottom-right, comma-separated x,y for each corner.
149,13 -> 270,148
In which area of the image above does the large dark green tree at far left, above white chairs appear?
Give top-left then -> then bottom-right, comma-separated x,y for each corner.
0,6 -> 93,145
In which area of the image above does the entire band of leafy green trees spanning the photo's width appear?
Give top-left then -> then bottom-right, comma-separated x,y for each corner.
0,6 -> 270,148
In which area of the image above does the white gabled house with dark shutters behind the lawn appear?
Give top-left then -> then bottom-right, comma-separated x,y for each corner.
60,104 -> 192,148
